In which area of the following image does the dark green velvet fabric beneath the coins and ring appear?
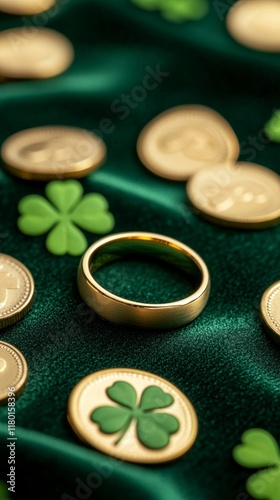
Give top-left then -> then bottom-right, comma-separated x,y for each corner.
0,0 -> 280,500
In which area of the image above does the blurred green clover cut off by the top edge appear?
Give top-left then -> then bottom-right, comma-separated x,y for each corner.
131,0 -> 208,22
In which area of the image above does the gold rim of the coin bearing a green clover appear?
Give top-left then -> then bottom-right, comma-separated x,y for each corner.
67,368 -> 198,464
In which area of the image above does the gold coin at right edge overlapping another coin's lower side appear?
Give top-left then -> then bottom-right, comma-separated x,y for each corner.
187,163 -> 280,229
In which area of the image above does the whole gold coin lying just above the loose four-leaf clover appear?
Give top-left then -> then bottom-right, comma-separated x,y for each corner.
1,126 -> 106,180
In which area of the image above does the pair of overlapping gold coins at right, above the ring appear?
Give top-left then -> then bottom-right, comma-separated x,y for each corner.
137,106 -> 280,229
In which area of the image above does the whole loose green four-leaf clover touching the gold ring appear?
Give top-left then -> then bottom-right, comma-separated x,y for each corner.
18,180 -> 114,255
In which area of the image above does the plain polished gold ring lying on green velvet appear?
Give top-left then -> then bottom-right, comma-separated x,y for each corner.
78,232 -> 210,329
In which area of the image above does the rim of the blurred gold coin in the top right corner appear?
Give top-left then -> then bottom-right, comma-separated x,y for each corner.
226,0 -> 280,52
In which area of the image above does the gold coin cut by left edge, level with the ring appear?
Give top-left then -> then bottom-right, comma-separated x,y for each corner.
0,253 -> 34,328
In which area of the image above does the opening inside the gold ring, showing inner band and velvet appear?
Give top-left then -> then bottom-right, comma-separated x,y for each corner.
89,239 -> 202,303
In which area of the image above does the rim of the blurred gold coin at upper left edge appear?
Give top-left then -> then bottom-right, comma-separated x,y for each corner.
0,27 -> 74,80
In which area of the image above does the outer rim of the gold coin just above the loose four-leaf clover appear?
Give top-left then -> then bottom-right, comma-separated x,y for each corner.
1,125 -> 107,181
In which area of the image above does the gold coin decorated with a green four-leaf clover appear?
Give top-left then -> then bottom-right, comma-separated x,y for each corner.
68,368 -> 198,464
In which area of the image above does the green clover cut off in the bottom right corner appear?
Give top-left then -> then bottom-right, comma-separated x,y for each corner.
233,429 -> 280,500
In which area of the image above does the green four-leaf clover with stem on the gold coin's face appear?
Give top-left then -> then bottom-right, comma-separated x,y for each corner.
91,382 -> 179,450
